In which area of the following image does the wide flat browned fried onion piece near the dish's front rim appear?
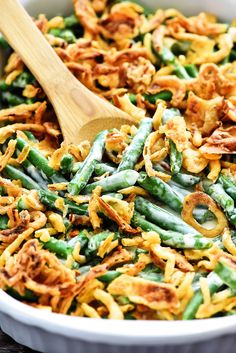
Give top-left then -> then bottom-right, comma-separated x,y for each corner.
107,274 -> 179,311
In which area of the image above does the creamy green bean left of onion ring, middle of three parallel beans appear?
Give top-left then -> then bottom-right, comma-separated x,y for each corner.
135,196 -> 198,234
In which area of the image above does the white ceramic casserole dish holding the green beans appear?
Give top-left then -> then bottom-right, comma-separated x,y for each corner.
0,0 -> 236,353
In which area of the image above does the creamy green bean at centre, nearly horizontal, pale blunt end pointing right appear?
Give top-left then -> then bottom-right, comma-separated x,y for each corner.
83,170 -> 139,194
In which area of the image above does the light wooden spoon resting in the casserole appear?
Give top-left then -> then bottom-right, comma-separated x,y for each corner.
0,0 -> 136,143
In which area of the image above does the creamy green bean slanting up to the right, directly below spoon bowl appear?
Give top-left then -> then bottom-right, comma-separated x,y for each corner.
68,130 -> 107,195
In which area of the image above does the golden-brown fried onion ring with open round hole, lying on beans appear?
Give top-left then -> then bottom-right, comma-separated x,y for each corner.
182,191 -> 228,238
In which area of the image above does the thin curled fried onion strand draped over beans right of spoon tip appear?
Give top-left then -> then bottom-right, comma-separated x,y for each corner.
143,131 -> 170,181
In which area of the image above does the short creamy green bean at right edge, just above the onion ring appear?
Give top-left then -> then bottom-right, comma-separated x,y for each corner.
202,179 -> 234,213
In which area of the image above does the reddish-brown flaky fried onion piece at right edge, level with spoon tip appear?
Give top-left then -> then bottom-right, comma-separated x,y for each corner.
200,126 -> 236,154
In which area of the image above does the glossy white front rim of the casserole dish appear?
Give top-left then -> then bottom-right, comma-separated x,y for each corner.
0,290 -> 236,344
